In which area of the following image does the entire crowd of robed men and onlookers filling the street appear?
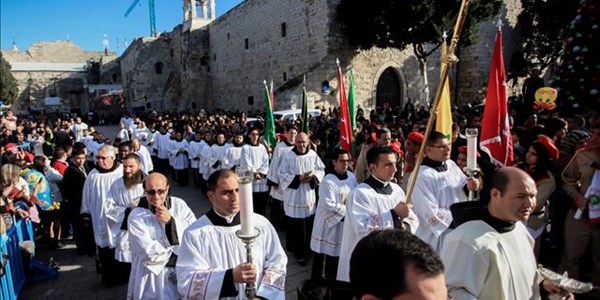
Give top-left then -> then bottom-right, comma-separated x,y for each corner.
0,97 -> 600,299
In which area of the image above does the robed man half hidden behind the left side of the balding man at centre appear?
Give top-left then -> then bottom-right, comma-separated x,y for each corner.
267,127 -> 298,227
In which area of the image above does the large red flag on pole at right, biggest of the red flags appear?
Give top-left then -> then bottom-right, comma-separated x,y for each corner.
481,28 -> 513,166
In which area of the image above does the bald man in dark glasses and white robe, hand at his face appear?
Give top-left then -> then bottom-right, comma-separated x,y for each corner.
127,173 -> 196,300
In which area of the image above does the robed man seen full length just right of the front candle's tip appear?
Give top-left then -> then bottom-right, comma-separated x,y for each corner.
240,128 -> 269,216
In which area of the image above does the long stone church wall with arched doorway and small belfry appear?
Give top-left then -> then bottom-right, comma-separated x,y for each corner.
120,0 -> 520,115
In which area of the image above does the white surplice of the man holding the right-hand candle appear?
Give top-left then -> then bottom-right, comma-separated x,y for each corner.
412,160 -> 467,253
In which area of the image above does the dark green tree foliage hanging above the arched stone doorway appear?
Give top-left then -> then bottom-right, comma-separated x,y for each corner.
338,0 -> 502,61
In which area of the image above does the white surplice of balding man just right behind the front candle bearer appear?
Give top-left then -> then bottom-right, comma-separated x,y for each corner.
279,150 -> 325,218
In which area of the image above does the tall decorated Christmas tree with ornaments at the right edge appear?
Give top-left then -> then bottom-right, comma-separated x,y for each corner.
550,0 -> 600,113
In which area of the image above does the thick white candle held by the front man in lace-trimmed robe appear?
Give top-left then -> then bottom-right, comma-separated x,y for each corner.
236,167 -> 255,236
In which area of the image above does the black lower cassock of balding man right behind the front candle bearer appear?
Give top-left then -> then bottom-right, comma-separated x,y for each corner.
285,215 -> 315,259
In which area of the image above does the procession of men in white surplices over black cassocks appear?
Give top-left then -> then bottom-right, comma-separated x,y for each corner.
72,120 -> 568,299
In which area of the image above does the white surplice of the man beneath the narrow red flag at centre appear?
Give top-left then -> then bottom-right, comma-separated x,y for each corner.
310,171 -> 356,257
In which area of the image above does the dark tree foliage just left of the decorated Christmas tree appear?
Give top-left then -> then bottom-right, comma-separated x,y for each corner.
509,0 -> 578,79
